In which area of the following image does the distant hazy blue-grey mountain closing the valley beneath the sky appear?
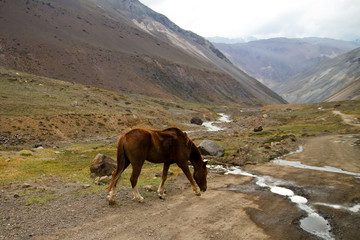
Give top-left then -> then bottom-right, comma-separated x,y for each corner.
214,38 -> 359,89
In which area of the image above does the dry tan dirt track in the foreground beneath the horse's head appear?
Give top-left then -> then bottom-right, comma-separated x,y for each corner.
38,175 -> 268,239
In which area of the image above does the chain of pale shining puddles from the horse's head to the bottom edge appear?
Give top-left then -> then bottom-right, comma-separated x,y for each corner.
209,165 -> 334,240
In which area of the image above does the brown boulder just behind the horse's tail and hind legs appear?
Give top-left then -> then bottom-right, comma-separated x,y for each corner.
90,153 -> 117,177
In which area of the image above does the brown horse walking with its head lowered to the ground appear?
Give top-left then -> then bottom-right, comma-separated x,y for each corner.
107,128 -> 207,204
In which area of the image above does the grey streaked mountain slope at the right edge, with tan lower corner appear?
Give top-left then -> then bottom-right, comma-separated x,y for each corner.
276,48 -> 360,103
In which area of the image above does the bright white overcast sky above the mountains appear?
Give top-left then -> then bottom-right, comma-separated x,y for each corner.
140,0 -> 360,40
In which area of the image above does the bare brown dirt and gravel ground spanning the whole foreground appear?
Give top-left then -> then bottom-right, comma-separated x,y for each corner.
0,132 -> 360,239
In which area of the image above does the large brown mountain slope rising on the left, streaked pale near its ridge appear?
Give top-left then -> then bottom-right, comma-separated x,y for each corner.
0,0 -> 285,104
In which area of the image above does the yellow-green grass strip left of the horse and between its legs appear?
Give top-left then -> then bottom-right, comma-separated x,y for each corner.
0,144 -> 180,190
